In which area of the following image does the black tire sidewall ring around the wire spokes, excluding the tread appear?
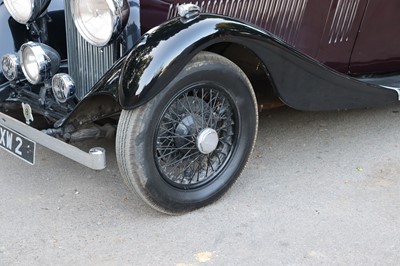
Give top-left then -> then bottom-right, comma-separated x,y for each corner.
131,54 -> 257,211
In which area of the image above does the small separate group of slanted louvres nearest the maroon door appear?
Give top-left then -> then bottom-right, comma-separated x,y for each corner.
329,0 -> 360,44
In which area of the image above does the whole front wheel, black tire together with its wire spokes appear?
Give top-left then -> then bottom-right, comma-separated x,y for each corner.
116,52 -> 258,214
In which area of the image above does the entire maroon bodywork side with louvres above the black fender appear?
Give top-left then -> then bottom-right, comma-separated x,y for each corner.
141,0 -> 400,74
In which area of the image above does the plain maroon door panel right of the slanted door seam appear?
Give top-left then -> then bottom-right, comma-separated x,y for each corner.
350,0 -> 400,73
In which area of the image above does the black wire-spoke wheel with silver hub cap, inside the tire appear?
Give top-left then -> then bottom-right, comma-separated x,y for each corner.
154,84 -> 235,189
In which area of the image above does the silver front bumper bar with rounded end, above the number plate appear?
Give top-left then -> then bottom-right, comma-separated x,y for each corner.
0,112 -> 106,170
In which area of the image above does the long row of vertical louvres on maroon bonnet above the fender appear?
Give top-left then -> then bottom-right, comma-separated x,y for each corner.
168,0 -> 308,45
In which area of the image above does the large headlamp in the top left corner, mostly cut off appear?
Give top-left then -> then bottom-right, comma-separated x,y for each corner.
4,0 -> 51,24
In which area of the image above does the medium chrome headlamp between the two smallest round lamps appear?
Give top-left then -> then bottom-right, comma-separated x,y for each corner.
19,42 -> 61,84
